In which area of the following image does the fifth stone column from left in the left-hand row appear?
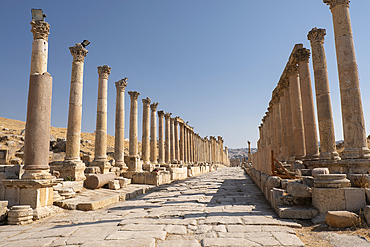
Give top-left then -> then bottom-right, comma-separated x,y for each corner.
128,91 -> 142,172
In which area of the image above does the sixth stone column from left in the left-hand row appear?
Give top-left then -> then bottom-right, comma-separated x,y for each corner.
141,97 -> 150,165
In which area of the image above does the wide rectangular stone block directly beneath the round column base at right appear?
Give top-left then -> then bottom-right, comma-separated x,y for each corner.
312,188 -> 346,213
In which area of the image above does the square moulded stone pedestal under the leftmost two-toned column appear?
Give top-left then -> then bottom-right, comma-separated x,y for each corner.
2,179 -> 57,209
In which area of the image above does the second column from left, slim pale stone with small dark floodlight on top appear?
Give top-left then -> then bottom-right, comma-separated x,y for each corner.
60,43 -> 88,181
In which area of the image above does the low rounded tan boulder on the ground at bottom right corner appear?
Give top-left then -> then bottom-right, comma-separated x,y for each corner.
325,211 -> 359,228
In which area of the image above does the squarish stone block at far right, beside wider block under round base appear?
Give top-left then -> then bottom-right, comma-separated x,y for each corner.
344,187 -> 366,212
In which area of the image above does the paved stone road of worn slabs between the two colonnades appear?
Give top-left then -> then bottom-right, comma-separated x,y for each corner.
0,168 -> 304,247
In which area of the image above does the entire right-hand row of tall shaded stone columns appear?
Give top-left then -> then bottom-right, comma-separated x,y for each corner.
254,0 -> 370,172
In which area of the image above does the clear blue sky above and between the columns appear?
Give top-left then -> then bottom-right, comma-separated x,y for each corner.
0,0 -> 370,148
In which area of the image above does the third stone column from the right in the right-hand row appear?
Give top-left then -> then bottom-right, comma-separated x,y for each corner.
294,48 -> 319,160
